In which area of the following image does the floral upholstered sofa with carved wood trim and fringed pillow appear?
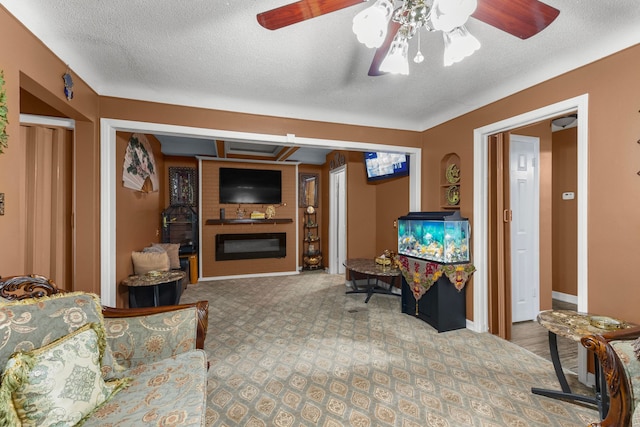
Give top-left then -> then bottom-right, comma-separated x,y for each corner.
0,276 -> 208,426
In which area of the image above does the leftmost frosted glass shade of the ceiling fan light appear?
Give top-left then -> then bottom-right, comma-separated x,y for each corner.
352,0 -> 393,48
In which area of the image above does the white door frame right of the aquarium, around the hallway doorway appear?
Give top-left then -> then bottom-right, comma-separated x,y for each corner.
468,94 -> 589,332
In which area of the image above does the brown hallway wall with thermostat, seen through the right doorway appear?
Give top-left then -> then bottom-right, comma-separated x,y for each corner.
552,128 -> 579,295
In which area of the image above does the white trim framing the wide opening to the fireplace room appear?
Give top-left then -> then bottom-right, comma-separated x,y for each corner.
100,118 -> 422,307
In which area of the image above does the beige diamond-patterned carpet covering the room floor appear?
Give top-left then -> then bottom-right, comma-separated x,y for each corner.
181,272 -> 597,427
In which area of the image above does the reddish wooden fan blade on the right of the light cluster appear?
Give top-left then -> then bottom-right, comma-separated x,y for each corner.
471,0 -> 560,40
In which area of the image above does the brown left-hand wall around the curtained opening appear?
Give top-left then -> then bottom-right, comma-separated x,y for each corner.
0,6 -> 100,292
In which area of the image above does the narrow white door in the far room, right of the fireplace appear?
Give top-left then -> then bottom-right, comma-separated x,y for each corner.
329,166 -> 347,274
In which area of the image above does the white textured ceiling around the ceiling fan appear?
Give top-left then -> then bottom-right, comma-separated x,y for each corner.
0,0 -> 640,131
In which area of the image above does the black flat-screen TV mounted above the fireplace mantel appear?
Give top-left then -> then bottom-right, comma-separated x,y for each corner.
220,168 -> 282,205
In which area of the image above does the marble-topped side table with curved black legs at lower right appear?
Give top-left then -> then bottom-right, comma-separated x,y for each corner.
531,310 -> 634,419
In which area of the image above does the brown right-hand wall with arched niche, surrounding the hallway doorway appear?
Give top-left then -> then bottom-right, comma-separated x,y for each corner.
422,45 -> 640,322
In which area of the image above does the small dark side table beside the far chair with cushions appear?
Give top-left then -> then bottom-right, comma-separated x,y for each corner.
121,270 -> 186,308
